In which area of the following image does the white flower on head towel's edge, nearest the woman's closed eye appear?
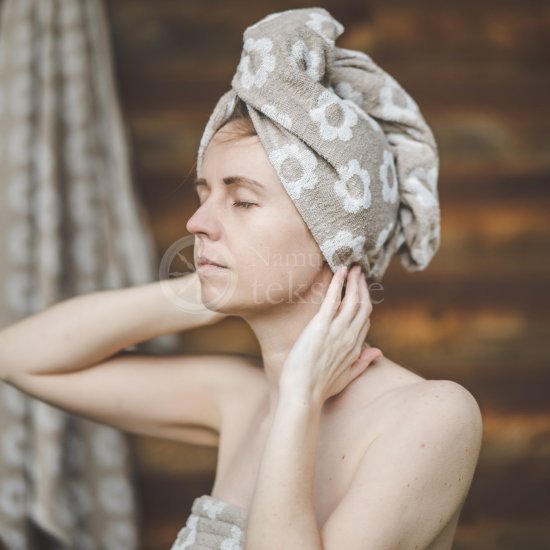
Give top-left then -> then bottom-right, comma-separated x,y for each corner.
269,143 -> 318,199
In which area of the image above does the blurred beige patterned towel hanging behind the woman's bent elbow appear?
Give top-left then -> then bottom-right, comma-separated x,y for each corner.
0,0 -> 173,550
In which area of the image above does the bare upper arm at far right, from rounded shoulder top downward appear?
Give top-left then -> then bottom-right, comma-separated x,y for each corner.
321,380 -> 483,550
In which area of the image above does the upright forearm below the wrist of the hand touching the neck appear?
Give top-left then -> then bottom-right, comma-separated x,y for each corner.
245,394 -> 322,550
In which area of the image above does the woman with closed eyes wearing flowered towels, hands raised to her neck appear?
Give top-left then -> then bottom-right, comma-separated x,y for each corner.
0,8 -> 481,550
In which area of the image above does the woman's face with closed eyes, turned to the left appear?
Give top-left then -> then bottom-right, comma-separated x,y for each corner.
187,123 -> 332,315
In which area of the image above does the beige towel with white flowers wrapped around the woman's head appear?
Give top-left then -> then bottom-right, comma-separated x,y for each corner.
197,8 -> 440,281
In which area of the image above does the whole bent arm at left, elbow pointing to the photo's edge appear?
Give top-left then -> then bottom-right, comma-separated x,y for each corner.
0,274 -> 237,446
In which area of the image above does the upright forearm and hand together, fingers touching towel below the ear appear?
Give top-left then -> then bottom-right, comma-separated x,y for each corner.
245,269 -> 381,550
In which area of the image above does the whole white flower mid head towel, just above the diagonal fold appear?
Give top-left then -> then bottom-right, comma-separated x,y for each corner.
309,90 -> 358,141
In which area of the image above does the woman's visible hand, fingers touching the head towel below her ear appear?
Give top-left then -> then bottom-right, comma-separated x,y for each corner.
279,266 -> 382,404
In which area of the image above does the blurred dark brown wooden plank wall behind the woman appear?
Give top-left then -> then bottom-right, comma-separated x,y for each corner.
102,0 -> 550,550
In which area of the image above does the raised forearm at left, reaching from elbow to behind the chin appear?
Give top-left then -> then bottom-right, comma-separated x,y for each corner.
0,273 -> 218,379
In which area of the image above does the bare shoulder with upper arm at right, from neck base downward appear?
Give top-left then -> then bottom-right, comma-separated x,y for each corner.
323,357 -> 482,550
